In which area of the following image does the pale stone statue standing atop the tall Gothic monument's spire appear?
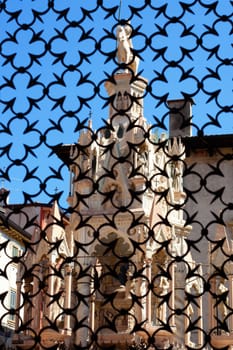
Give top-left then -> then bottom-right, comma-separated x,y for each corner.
116,25 -> 139,74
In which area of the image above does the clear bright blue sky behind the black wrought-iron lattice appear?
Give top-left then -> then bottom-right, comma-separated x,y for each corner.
0,0 -> 233,203
